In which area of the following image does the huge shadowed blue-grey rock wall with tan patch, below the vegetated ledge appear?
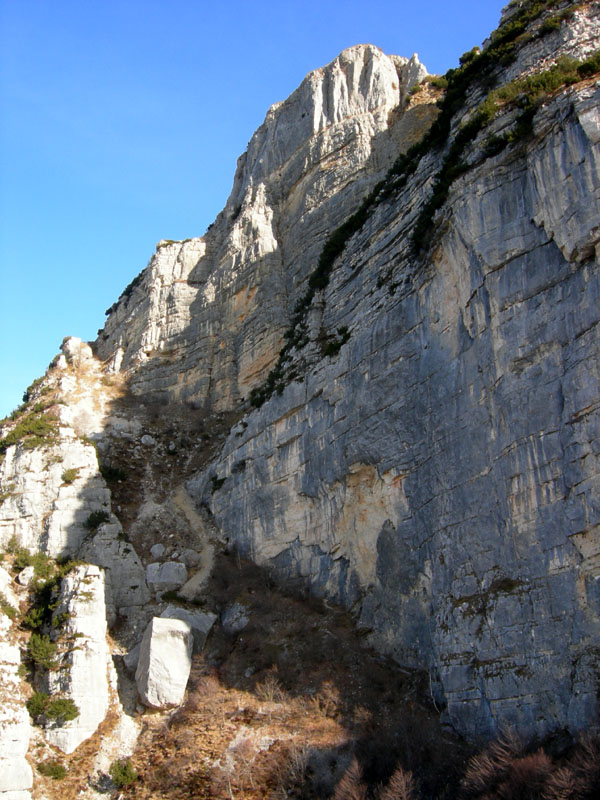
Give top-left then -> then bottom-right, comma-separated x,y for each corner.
200,75 -> 600,735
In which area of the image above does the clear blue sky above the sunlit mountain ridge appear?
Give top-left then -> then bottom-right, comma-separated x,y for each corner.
0,0 -> 503,416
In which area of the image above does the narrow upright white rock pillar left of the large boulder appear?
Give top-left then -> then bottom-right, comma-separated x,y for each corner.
46,565 -> 110,753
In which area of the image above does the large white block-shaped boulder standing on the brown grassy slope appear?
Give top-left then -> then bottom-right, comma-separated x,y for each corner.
135,617 -> 194,708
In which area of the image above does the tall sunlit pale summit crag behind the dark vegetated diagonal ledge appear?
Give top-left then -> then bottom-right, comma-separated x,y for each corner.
95,45 -> 435,410
